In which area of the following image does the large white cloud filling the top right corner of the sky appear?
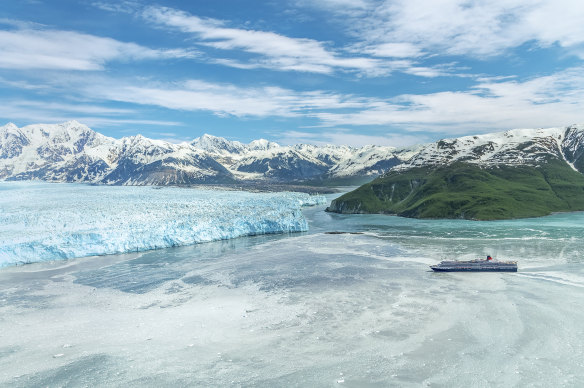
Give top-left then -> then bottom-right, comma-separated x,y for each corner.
318,0 -> 584,58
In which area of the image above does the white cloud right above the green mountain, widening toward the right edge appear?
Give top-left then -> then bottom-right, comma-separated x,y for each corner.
315,67 -> 584,135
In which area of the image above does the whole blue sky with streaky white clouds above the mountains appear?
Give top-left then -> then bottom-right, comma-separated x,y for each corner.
0,0 -> 584,147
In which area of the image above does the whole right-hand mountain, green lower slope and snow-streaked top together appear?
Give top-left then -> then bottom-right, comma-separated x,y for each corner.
327,125 -> 584,220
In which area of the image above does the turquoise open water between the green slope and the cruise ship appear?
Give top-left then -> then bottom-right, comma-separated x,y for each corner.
320,208 -> 584,269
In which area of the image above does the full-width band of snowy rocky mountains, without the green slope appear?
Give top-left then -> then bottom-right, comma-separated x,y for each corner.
9,121 -> 584,185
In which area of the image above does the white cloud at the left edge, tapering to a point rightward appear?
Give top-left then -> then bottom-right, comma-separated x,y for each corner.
0,29 -> 194,71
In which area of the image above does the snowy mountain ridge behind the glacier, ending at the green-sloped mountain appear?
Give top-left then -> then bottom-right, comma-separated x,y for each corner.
0,121 -> 415,185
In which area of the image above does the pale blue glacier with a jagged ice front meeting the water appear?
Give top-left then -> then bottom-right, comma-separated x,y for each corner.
0,182 -> 326,267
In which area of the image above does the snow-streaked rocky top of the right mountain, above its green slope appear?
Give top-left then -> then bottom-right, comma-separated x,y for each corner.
394,125 -> 584,172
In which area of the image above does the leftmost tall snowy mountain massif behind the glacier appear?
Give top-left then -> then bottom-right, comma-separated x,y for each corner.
0,121 -> 233,185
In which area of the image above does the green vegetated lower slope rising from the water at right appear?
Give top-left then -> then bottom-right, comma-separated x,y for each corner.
327,159 -> 584,220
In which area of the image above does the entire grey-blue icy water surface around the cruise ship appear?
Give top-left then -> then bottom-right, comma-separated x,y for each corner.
0,189 -> 584,387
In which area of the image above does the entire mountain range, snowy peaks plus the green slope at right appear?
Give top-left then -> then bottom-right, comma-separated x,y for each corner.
0,121 -> 584,220
